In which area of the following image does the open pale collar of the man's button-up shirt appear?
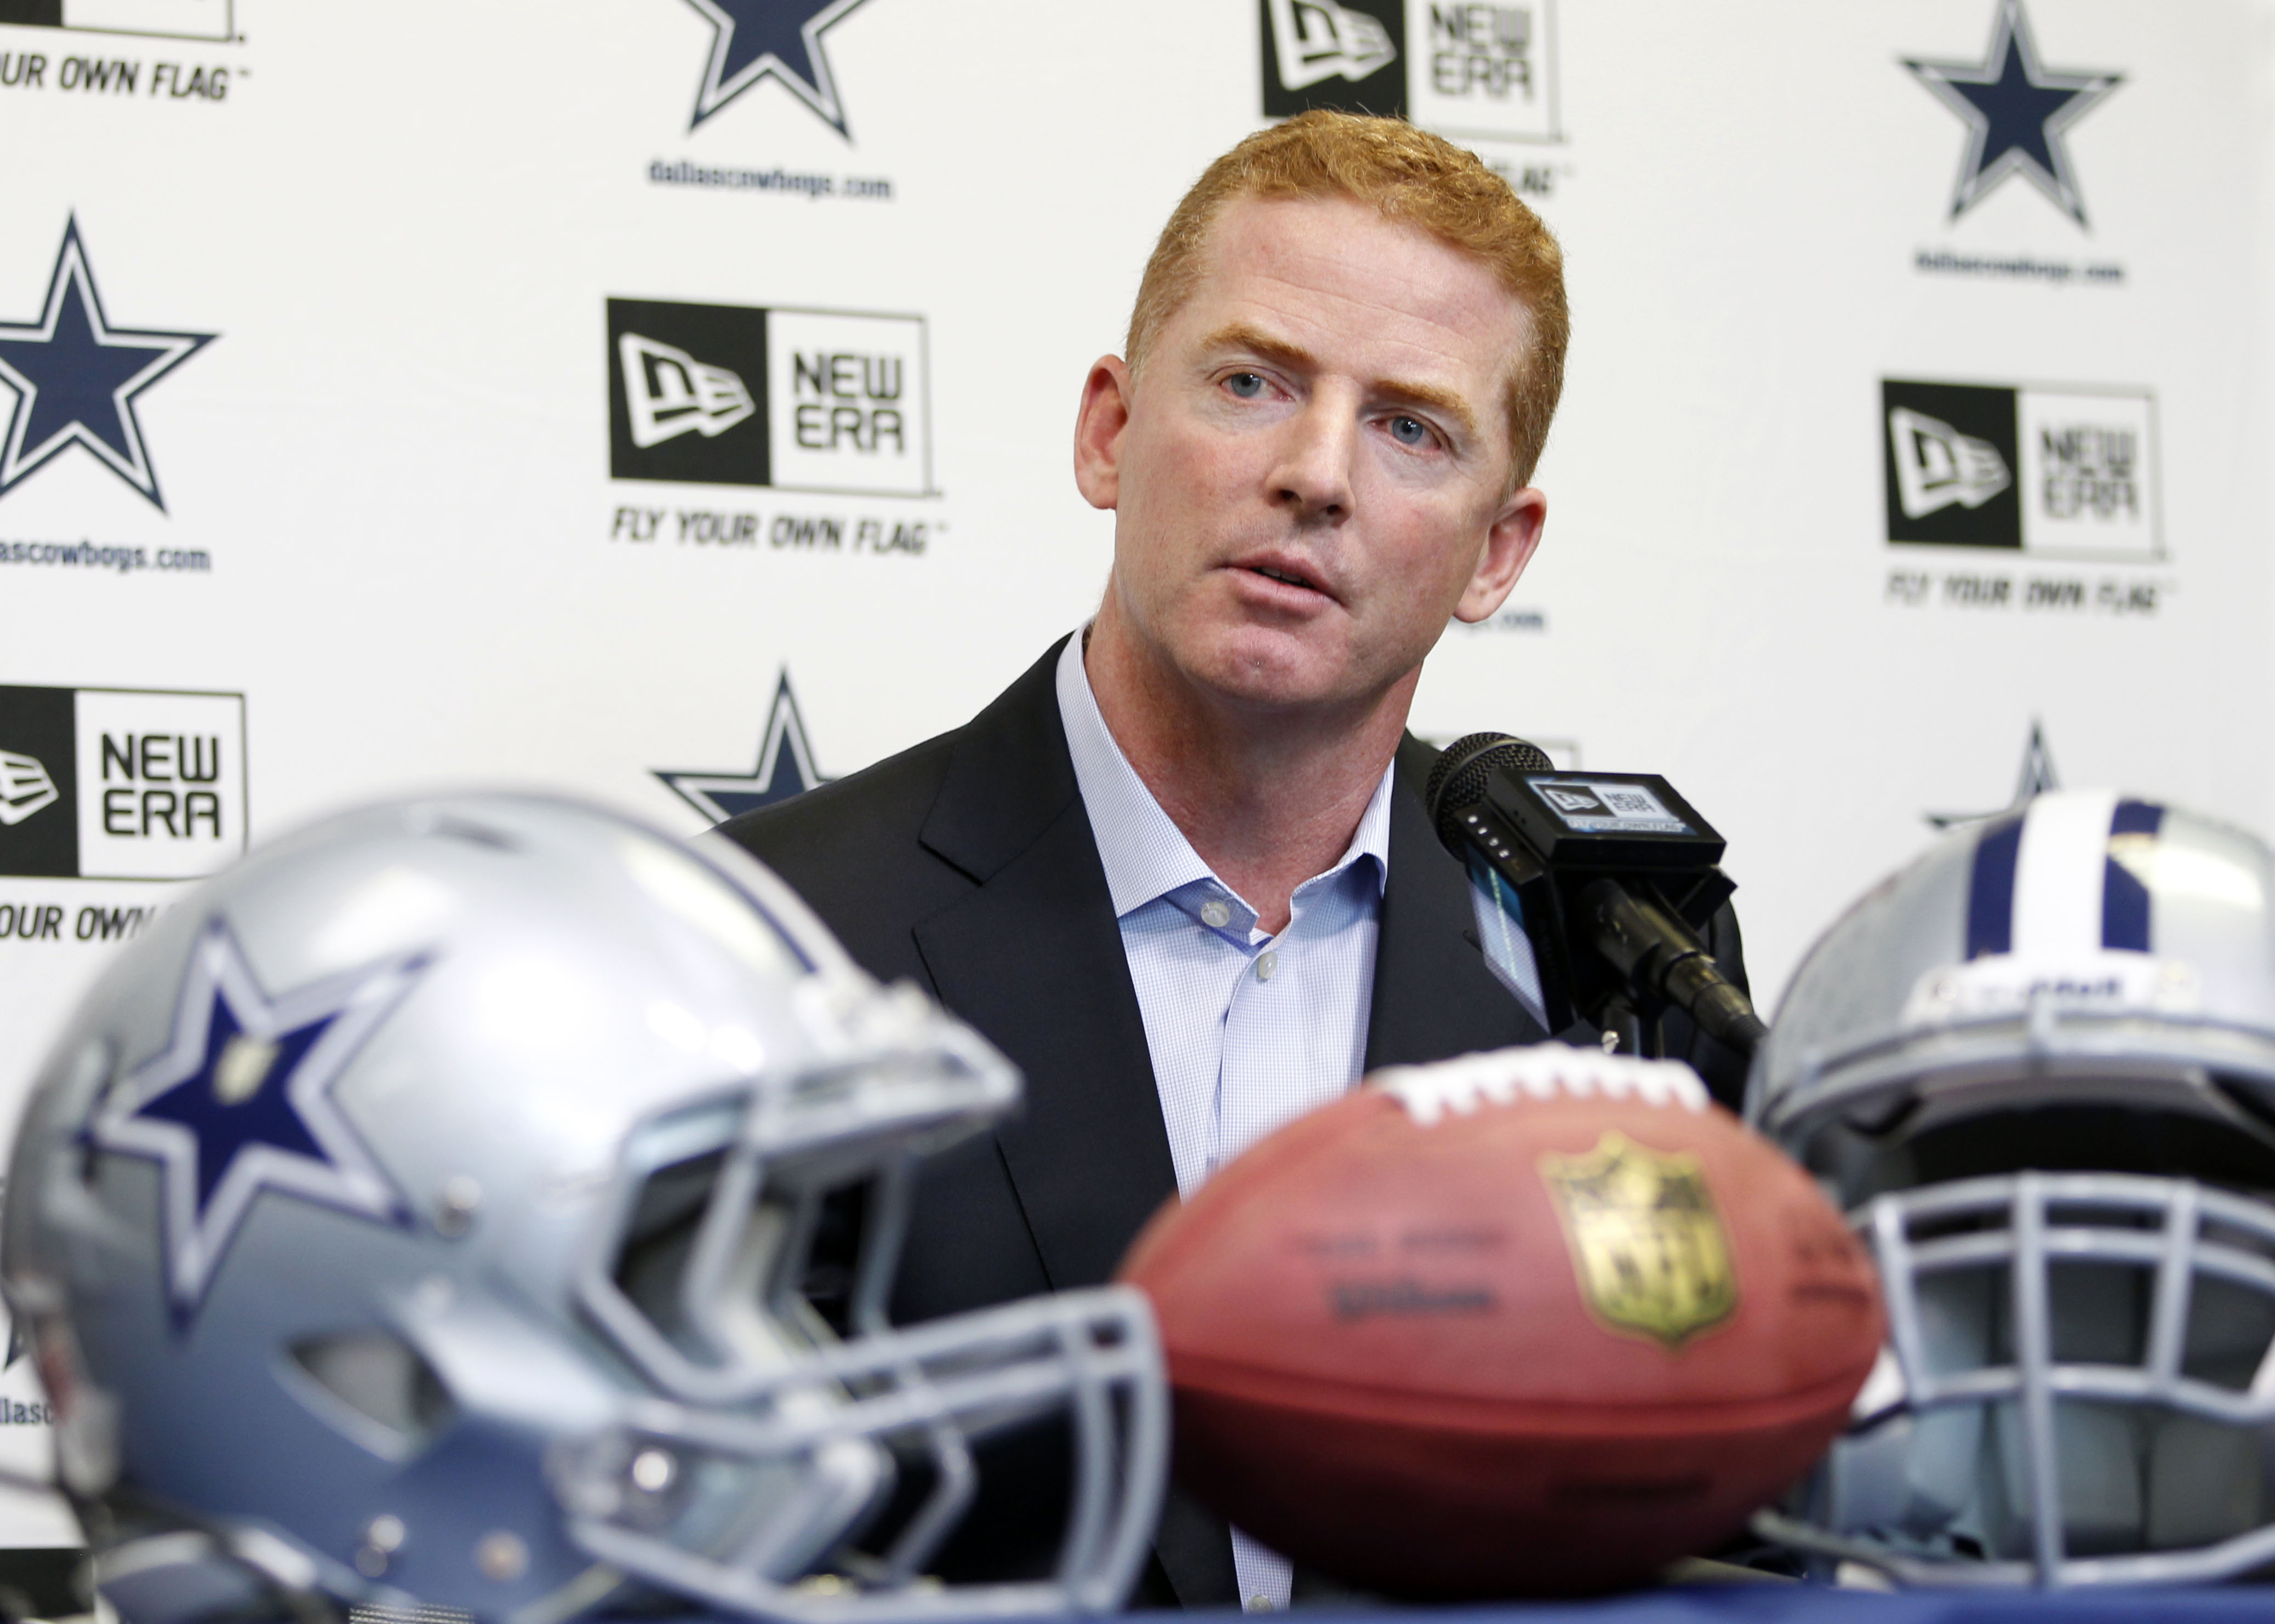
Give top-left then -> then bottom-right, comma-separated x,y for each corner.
1058,626 -> 1392,919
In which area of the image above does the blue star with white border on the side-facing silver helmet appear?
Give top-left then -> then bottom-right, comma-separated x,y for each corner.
89,923 -> 423,1324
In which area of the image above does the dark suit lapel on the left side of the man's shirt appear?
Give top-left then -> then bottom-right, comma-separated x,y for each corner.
914,644 -> 1176,1290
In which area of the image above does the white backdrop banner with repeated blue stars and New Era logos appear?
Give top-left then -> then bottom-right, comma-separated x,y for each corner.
0,0 -> 2275,1547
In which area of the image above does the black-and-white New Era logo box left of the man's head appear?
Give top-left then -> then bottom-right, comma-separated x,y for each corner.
608,298 -> 933,496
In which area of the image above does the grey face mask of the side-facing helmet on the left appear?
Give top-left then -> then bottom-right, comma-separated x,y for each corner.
566,1055 -> 1165,1615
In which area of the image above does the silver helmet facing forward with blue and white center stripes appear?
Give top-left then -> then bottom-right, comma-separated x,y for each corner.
1747,794 -> 2275,1585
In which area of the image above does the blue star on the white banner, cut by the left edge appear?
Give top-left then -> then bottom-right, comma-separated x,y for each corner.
0,219 -> 219,512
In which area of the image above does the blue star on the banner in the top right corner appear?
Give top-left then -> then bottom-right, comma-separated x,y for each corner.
1904,0 -> 2125,225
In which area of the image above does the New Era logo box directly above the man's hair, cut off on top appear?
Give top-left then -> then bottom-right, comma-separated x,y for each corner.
1258,0 -> 1563,141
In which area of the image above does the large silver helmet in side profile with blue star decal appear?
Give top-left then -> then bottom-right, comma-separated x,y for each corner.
4,794 -> 1167,1624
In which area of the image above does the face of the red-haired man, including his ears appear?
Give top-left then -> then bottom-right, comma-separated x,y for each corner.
1076,198 -> 1545,707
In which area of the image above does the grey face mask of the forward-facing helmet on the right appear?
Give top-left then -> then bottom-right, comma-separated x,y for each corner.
1797,1155 -> 2275,1583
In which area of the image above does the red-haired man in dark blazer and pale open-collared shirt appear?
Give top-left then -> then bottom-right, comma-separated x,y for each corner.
723,111 -> 1736,1606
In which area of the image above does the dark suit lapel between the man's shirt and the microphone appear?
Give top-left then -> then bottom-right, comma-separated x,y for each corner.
1367,735 -> 1547,1071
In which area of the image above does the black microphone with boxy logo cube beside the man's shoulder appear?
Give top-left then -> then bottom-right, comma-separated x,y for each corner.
1424,733 -> 1770,1057
